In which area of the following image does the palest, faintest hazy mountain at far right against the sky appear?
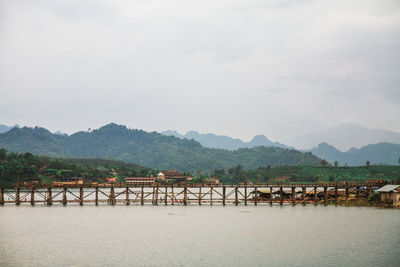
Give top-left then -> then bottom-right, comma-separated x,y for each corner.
288,124 -> 400,151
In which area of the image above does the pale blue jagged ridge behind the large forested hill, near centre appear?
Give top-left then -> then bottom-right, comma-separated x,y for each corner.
162,130 -> 289,150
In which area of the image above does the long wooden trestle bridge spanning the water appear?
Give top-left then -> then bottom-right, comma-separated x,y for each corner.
0,183 -> 373,206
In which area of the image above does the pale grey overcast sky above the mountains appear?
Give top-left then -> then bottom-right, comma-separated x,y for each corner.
0,0 -> 400,141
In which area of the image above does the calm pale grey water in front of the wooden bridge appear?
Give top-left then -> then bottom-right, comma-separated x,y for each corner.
0,205 -> 400,266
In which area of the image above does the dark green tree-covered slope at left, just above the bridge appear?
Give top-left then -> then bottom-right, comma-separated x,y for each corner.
0,148 -> 157,184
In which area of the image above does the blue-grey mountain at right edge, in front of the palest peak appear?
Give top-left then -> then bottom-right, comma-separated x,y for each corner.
310,143 -> 400,166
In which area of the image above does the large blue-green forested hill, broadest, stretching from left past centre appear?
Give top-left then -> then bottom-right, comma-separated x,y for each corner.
0,123 -> 321,171
